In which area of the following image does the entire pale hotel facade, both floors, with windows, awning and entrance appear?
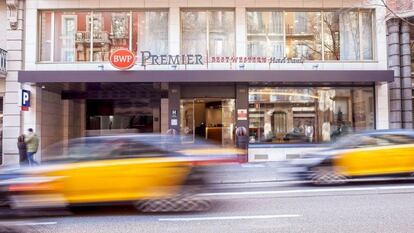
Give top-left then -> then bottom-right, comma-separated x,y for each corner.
0,0 -> 394,164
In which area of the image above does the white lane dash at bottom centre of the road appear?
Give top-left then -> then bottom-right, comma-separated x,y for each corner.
158,214 -> 301,222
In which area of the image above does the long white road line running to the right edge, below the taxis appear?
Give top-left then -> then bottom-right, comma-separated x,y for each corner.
200,185 -> 414,196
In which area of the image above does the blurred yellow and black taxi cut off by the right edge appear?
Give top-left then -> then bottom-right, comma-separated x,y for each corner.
291,130 -> 414,184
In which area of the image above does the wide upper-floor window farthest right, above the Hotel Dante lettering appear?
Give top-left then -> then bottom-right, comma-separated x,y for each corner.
246,10 -> 374,60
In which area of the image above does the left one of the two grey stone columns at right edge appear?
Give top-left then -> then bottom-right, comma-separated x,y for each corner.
387,19 -> 402,129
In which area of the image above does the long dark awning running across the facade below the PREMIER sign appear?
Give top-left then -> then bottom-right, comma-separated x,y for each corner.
18,70 -> 394,83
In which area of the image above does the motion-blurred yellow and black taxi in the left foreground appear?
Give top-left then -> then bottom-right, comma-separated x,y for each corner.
0,135 -> 243,212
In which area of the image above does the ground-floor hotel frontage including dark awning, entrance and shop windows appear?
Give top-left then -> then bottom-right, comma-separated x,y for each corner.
8,71 -> 393,164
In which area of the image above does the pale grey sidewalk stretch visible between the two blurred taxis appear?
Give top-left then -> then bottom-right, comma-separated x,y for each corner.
210,162 -> 292,184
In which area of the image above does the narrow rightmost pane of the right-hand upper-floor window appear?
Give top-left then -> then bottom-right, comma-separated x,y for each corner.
361,12 -> 373,60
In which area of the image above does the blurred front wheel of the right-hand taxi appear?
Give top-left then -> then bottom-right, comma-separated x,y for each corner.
309,166 -> 347,185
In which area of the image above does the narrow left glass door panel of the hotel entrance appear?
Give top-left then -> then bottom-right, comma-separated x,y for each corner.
180,99 -> 195,142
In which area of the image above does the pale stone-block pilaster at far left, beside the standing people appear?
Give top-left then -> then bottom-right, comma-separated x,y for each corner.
2,0 -> 24,165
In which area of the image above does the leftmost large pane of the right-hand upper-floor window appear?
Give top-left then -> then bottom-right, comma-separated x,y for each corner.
247,11 -> 285,58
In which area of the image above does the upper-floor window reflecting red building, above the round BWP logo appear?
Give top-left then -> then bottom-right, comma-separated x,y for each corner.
39,11 -> 168,62
